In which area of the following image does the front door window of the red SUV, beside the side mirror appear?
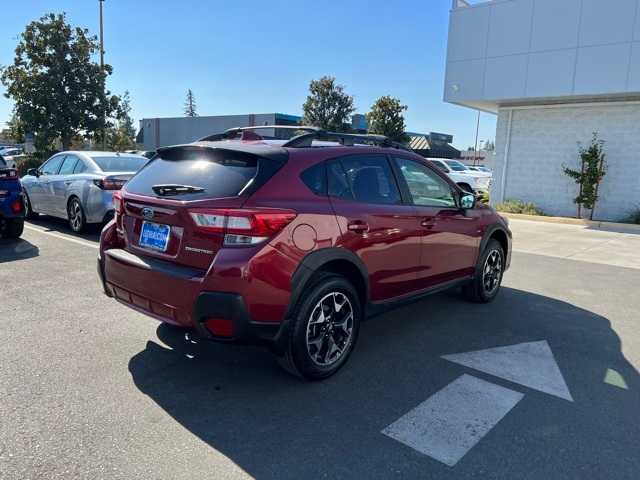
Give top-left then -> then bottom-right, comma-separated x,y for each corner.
394,157 -> 457,207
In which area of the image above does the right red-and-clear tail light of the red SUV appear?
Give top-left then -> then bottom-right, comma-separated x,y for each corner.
189,209 -> 297,245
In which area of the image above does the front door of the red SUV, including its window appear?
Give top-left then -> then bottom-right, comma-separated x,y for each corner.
393,155 -> 482,288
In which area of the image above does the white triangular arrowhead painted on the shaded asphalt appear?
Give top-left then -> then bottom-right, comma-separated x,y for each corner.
442,340 -> 573,402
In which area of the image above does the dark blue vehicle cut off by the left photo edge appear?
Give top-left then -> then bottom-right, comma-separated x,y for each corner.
0,156 -> 25,238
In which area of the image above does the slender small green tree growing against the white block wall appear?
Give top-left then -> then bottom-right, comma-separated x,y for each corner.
562,132 -> 606,220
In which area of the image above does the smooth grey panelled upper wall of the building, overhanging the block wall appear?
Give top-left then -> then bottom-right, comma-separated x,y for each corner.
444,0 -> 640,111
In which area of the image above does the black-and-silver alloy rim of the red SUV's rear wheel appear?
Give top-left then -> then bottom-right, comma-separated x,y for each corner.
307,292 -> 353,367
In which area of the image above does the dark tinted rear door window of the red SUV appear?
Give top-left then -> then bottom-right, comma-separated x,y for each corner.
341,155 -> 402,205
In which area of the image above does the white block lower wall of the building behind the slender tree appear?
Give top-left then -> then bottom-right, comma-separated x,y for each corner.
491,103 -> 640,221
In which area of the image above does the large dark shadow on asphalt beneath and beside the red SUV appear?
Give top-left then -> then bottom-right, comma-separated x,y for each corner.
129,288 -> 640,478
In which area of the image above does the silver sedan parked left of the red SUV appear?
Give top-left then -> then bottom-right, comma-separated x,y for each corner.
22,151 -> 148,232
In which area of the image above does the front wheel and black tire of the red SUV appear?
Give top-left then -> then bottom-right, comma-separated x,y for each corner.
463,239 -> 505,303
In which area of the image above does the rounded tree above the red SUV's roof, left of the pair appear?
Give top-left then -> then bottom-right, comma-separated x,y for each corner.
302,76 -> 355,132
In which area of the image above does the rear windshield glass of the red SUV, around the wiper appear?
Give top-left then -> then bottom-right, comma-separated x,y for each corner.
126,148 -> 260,200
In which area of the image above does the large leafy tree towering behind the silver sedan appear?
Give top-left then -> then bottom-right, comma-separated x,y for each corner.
0,13 -> 119,149
